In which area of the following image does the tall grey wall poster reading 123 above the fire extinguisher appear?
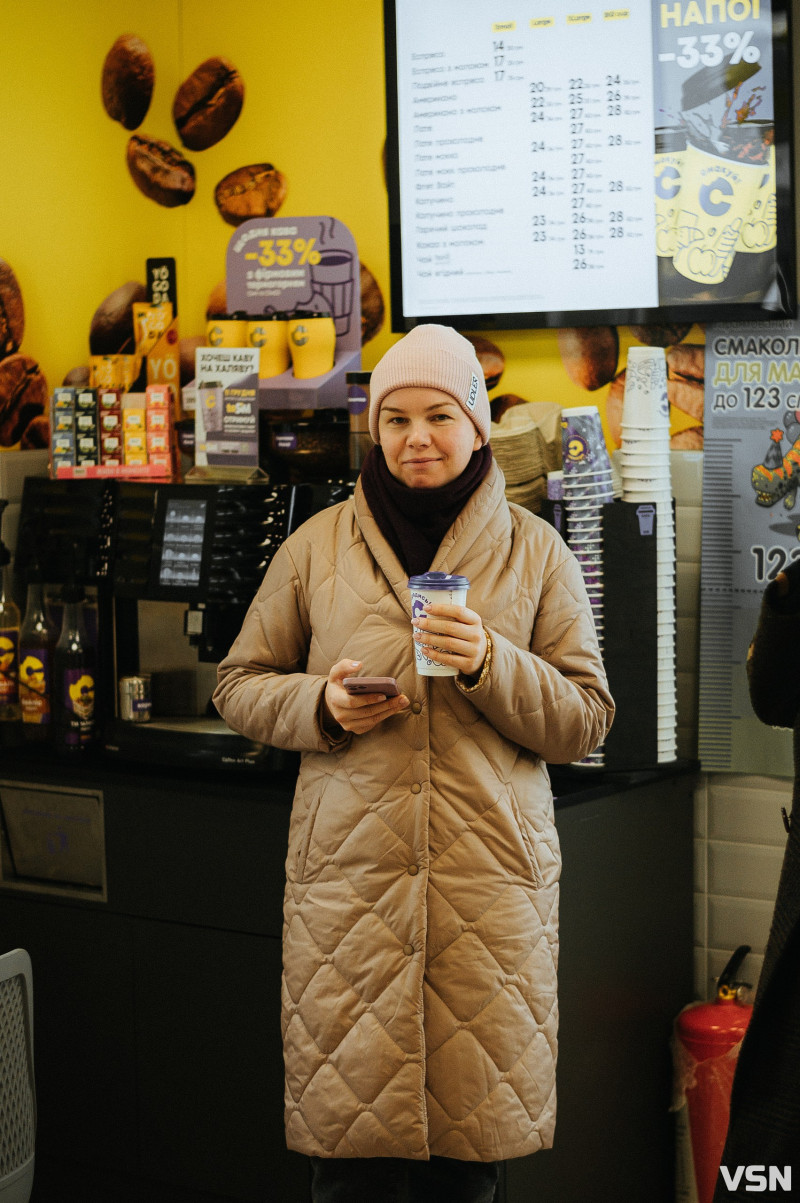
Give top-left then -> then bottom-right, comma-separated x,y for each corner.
699,321 -> 800,777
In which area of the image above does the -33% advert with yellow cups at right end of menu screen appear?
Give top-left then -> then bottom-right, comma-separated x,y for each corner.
653,0 -> 778,306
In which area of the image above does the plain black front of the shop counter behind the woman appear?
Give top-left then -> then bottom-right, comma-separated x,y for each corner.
0,751 -> 697,1203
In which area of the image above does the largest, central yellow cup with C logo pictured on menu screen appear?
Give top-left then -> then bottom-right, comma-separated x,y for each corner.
672,143 -> 764,285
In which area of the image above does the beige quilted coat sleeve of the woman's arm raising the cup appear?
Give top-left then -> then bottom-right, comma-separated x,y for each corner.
454,556 -> 614,764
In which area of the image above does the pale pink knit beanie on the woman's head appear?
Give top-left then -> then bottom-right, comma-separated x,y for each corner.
369,322 -> 492,446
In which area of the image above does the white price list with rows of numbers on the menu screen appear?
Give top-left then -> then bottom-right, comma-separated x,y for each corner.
397,0 -> 658,324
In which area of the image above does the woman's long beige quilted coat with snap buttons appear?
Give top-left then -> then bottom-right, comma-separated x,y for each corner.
214,466 -> 614,1161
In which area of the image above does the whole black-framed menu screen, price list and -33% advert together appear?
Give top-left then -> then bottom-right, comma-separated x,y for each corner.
386,0 -> 795,330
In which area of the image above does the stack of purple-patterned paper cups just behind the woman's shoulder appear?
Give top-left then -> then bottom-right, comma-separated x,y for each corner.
561,405 -> 614,765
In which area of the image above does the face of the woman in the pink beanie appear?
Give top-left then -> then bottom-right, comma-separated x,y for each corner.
378,387 -> 481,488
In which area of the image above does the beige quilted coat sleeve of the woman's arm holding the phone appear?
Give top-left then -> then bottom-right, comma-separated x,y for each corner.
213,544 -> 344,752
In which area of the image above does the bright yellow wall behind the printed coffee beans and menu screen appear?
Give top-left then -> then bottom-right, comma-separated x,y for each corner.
0,0 -> 703,447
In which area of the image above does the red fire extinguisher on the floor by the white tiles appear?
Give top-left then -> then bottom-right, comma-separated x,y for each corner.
672,944 -> 753,1203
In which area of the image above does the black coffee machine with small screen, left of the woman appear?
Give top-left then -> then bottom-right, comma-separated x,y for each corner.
16,478 -> 354,770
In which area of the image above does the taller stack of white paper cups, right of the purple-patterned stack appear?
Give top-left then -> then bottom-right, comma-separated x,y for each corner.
620,346 -> 677,763
